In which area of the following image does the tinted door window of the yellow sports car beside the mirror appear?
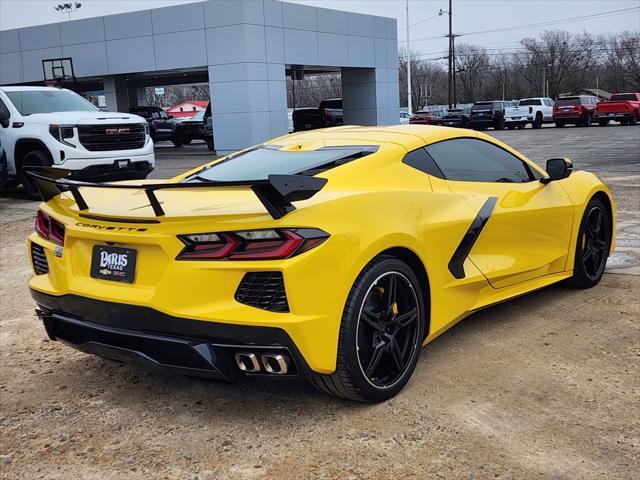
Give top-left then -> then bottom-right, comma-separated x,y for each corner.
426,138 -> 540,183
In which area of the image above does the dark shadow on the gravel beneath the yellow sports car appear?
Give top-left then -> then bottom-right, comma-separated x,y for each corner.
43,285 -> 575,421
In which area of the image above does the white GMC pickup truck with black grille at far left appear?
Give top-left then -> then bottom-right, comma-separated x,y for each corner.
0,87 -> 155,199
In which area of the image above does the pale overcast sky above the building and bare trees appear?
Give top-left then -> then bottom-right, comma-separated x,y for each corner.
0,0 -> 640,58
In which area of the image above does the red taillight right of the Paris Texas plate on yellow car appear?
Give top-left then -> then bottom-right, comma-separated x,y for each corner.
177,228 -> 329,260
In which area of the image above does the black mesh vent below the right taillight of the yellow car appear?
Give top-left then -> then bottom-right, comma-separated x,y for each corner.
235,272 -> 289,312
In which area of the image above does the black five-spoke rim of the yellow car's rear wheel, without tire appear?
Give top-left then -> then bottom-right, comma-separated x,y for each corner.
356,272 -> 420,389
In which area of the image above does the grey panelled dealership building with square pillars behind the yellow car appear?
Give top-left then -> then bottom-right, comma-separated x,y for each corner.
0,0 -> 399,153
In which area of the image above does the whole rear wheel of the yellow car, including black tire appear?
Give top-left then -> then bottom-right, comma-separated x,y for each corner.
311,255 -> 427,402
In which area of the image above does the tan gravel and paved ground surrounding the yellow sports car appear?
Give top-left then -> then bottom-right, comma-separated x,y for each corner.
0,126 -> 640,479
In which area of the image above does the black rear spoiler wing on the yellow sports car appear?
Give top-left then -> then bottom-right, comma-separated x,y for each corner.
23,166 -> 327,219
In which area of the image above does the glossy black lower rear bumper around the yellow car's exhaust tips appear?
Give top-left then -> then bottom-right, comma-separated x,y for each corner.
31,290 -> 310,382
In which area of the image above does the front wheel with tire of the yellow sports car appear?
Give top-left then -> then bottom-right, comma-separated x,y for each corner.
569,198 -> 611,288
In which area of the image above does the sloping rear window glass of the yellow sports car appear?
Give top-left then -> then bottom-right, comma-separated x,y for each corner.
185,145 -> 378,182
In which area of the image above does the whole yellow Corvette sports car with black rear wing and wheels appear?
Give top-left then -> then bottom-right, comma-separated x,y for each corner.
29,125 -> 615,402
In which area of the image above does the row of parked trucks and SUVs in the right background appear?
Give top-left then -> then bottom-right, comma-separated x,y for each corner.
408,93 -> 640,130
